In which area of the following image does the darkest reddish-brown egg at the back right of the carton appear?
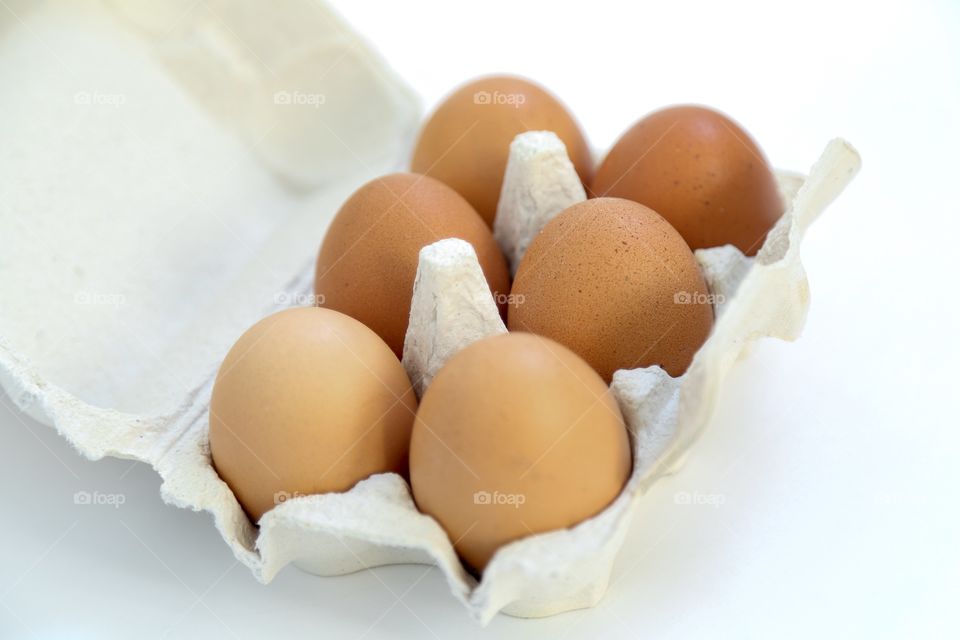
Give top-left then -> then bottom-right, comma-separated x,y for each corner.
592,106 -> 783,256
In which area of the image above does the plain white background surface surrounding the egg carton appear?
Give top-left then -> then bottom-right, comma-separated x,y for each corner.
0,0 -> 960,638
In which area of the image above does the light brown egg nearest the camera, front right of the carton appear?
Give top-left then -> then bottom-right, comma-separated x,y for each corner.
410,333 -> 631,571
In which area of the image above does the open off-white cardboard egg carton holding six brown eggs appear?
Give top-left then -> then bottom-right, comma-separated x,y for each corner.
0,2 -> 859,624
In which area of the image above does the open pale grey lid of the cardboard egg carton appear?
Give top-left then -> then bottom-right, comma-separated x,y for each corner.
0,2 -> 420,430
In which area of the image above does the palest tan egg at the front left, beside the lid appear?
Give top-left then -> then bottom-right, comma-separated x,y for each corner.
210,307 -> 417,522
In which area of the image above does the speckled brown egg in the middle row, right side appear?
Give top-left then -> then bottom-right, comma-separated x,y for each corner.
507,198 -> 713,382
